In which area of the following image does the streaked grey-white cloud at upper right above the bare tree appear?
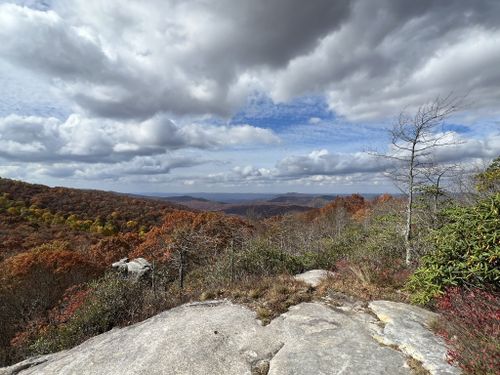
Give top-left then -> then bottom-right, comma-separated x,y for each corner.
273,0 -> 500,119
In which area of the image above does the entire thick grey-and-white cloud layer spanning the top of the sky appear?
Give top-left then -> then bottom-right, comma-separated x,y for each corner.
0,0 -> 500,119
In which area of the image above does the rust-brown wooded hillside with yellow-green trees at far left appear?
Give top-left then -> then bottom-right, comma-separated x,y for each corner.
0,178 -> 186,260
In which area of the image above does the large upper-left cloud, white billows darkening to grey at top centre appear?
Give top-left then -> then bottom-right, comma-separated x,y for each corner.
0,0 -> 349,118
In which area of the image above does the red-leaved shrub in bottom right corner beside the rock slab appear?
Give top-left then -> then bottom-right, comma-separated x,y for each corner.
437,287 -> 500,374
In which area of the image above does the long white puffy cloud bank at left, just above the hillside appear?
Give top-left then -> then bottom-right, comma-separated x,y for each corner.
0,114 -> 279,163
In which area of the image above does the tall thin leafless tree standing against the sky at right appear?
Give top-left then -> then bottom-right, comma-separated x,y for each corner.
374,94 -> 464,265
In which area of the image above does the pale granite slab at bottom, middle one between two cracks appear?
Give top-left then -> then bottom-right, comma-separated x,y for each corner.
269,303 -> 410,375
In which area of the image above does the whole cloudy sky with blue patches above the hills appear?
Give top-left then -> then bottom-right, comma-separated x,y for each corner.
0,0 -> 500,193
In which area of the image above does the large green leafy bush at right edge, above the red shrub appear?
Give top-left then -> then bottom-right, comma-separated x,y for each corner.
407,193 -> 500,304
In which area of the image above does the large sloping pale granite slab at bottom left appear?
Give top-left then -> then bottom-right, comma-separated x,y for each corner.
0,301 -> 282,375
